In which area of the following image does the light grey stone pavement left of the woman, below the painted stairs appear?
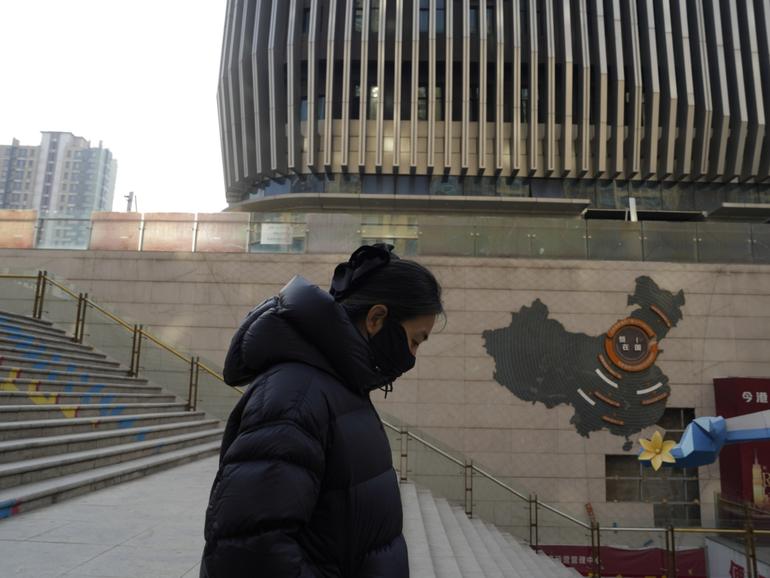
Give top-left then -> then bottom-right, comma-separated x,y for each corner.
0,457 -> 218,578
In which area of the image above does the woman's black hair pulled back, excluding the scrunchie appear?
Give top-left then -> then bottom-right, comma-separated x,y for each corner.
340,259 -> 444,323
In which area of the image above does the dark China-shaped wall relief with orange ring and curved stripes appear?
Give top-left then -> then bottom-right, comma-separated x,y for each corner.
483,276 -> 685,450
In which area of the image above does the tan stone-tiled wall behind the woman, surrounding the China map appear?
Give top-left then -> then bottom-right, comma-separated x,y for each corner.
0,250 -> 770,540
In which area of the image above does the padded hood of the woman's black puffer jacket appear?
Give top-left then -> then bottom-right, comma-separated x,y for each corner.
223,276 -> 391,393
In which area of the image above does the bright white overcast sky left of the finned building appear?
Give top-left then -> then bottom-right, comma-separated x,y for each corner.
0,0 -> 226,212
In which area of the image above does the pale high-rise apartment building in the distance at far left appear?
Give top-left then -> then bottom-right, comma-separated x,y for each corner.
0,132 -> 117,246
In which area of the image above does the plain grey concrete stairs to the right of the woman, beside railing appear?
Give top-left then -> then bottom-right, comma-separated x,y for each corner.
401,483 -> 580,578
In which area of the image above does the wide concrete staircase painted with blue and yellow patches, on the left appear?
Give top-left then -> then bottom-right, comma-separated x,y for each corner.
0,311 -> 223,519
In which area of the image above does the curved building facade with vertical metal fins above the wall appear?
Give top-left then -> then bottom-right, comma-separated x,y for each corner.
218,0 -> 770,210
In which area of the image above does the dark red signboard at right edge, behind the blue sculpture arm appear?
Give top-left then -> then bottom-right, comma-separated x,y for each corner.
714,377 -> 770,509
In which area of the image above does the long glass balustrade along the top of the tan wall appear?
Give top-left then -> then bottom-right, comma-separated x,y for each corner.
0,212 -> 770,264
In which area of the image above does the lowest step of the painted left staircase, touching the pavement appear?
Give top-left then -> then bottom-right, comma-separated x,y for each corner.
0,442 -> 220,518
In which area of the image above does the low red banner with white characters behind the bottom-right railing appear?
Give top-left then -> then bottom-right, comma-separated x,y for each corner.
538,546 -> 707,578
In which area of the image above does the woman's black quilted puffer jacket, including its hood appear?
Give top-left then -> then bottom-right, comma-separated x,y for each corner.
201,277 -> 409,578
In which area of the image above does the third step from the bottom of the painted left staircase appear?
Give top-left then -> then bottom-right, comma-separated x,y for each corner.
0,419 -> 221,463
